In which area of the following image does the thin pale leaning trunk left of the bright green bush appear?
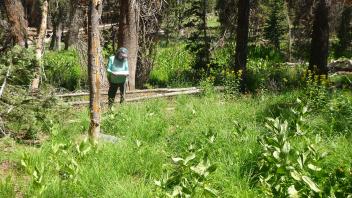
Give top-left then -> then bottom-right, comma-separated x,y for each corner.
31,0 -> 48,92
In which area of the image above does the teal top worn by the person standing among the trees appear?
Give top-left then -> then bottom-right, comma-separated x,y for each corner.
107,56 -> 128,83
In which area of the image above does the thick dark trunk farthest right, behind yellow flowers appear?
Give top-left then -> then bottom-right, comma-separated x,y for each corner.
309,0 -> 329,75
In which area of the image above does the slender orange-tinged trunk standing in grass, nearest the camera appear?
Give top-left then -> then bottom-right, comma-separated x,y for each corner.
88,0 -> 102,142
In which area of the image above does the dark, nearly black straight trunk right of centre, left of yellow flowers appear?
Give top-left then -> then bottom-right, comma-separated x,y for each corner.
234,0 -> 249,92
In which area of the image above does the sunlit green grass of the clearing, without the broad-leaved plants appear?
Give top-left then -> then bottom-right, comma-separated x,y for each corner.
0,89 -> 352,197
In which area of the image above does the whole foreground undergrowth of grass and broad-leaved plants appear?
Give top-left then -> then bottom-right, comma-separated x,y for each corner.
0,85 -> 352,197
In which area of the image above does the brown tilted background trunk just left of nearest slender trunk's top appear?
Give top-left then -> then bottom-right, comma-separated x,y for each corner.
65,0 -> 82,50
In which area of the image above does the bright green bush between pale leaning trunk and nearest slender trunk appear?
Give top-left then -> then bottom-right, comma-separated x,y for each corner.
44,50 -> 88,90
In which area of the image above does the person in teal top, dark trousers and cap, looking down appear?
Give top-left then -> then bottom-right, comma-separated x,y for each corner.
107,47 -> 129,109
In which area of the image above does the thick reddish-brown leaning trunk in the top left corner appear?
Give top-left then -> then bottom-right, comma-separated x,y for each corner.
4,0 -> 28,47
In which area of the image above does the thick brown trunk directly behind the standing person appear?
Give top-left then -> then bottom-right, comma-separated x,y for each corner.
118,0 -> 139,90
